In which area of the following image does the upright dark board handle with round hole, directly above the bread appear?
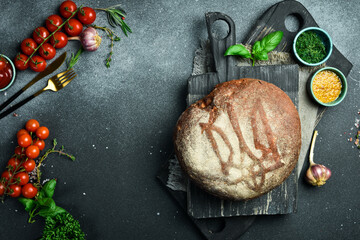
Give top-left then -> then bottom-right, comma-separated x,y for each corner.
205,12 -> 236,83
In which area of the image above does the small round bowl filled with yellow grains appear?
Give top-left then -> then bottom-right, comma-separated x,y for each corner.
308,67 -> 347,107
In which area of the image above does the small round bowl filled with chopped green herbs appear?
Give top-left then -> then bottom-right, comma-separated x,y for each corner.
293,27 -> 333,66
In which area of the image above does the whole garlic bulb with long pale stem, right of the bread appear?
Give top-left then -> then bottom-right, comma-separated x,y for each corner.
305,130 -> 331,187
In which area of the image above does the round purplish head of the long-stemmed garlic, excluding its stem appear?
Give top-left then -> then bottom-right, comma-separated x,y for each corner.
305,164 -> 331,187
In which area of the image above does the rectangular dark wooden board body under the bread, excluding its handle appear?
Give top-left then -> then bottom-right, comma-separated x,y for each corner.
187,65 -> 299,218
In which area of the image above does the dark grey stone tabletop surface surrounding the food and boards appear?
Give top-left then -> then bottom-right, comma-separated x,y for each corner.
0,0 -> 360,240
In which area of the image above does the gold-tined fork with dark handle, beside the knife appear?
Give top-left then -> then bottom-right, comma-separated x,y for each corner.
0,69 -> 77,119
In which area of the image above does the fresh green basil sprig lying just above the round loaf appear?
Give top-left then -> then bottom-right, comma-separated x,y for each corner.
224,31 -> 284,66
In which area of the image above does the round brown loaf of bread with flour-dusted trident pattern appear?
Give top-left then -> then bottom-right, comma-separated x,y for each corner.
174,78 -> 301,200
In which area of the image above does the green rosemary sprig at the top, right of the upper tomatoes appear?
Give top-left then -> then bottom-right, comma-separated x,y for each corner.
95,4 -> 132,36
